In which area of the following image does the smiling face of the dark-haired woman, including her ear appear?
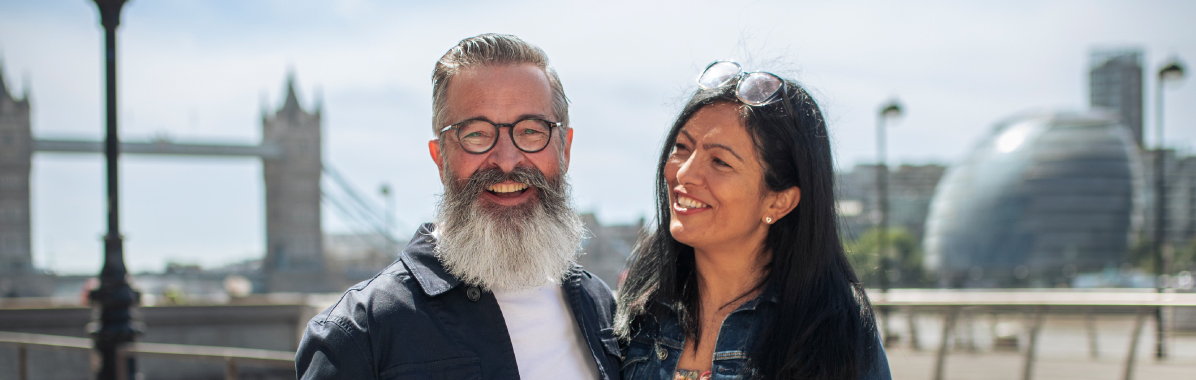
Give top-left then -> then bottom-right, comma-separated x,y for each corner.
665,103 -> 797,251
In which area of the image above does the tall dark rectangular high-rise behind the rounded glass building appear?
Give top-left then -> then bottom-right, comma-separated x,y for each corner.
1088,48 -> 1142,147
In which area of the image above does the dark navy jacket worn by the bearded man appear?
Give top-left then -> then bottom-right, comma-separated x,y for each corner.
295,223 -> 620,380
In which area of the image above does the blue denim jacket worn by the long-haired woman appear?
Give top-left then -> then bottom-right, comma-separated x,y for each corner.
622,294 -> 891,380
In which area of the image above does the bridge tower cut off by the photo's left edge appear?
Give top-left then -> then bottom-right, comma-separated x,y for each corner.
0,65 -> 54,296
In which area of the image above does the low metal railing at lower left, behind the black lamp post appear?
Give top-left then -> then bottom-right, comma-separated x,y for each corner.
0,331 -> 294,380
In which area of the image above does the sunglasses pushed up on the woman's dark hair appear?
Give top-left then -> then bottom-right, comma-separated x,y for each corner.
697,61 -> 785,105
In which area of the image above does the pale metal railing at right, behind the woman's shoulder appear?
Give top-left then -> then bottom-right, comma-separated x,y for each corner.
868,290 -> 1196,380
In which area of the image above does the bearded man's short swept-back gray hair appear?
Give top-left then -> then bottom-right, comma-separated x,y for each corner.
432,33 -> 569,136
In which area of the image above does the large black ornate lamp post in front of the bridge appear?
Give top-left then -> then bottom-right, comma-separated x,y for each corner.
89,0 -> 140,380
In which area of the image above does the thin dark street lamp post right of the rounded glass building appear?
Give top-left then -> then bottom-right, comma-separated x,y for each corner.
1151,59 -> 1184,358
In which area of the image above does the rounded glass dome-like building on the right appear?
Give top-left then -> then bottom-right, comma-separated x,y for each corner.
923,111 -> 1143,288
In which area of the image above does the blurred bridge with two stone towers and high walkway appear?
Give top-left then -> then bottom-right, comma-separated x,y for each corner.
0,73 -> 382,296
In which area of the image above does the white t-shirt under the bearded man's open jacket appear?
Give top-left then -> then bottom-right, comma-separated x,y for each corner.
494,283 -> 598,380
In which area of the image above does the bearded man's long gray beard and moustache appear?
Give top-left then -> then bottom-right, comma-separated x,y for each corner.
434,167 -> 586,292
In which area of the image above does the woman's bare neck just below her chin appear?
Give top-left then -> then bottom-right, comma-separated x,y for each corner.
694,241 -> 771,312
